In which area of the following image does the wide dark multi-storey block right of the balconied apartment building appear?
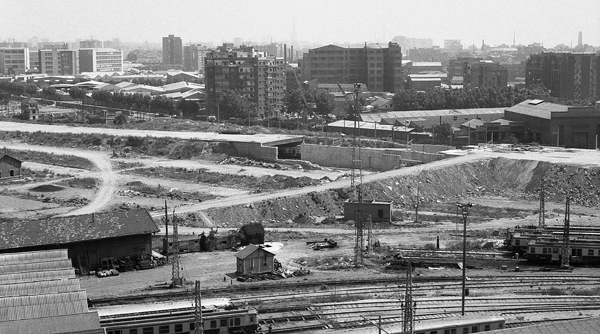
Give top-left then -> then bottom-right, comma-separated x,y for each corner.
302,42 -> 403,93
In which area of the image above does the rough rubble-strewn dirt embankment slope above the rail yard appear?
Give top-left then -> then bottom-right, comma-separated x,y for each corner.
207,158 -> 600,227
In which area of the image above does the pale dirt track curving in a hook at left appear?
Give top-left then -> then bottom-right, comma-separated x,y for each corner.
0,141 -> 119,216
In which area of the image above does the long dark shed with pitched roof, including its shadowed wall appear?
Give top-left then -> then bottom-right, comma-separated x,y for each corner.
0,209 -> 159,274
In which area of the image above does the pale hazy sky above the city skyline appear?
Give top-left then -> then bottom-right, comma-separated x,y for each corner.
0,0 -> 600,47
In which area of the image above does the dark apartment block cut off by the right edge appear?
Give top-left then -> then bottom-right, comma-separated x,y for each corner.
525,52 -> 600,100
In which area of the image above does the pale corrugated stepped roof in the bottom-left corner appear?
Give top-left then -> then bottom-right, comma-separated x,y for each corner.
0,249 -> 104,334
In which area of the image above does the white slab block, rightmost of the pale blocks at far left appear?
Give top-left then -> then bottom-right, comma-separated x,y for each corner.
78,49 -> 123,72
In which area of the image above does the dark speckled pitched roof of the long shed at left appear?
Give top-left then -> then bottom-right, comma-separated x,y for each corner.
0,209 -> 159,250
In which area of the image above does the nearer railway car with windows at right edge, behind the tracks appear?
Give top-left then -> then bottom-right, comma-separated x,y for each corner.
524,238 -> 600,265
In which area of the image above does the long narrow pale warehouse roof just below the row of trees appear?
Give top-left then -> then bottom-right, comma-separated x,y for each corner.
360,108 -> 505,123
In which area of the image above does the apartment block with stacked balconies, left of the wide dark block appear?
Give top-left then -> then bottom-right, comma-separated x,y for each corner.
205,51 -> 286,117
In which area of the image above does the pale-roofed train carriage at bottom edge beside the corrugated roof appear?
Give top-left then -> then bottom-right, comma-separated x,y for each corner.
98,299 -> 259,334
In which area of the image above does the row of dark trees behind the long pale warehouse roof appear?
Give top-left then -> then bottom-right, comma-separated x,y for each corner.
393,86 -> 532,110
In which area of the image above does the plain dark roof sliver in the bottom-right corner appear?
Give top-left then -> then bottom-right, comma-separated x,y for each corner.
486,317 -> 600,334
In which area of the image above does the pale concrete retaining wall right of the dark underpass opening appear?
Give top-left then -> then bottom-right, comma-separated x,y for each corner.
300,144 -> 444,170
